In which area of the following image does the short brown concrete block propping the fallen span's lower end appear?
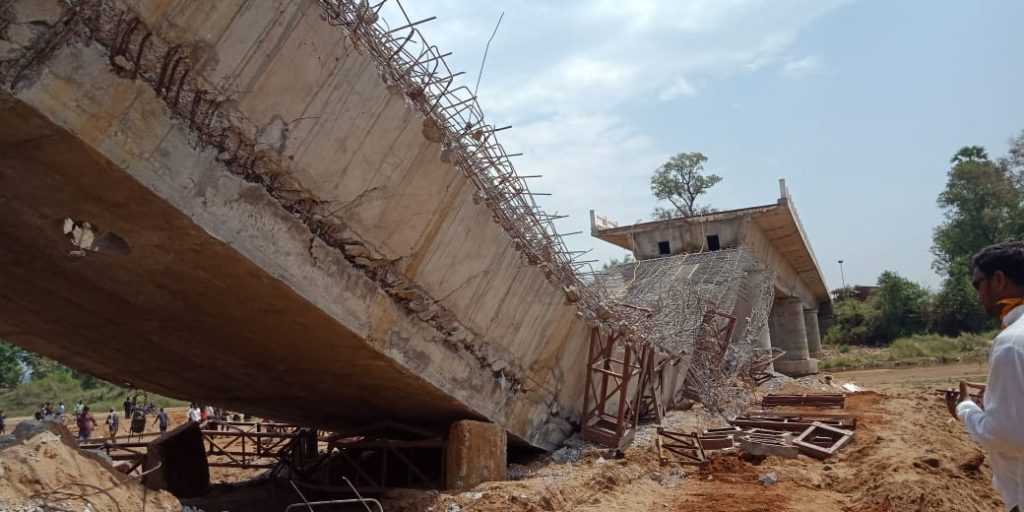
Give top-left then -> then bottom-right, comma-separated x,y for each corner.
444,420 -> 508,490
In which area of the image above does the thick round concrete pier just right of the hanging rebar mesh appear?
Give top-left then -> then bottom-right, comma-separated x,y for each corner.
768,297 -> 818,377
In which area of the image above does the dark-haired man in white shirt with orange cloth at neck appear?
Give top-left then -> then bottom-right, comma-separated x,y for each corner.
950,242 -> 1024,512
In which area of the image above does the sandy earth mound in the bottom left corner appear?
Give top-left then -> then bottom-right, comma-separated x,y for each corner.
0,422 -> 181,512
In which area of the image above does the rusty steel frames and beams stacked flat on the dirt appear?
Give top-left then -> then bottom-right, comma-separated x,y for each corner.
655,394 -> 857,467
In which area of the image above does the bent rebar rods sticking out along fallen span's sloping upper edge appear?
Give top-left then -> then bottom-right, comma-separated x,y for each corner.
317,0 -> 602,321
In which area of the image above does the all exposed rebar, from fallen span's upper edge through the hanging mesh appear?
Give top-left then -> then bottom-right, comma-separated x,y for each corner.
317,0 -> 771,413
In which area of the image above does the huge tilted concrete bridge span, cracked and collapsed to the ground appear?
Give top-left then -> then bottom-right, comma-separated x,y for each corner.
0,0 -> 588,447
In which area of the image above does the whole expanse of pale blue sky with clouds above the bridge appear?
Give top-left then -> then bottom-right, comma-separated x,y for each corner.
384,0 -> 1024,288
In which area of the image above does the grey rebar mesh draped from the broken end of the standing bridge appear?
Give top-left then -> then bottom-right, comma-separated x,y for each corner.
595,247 -> 774,408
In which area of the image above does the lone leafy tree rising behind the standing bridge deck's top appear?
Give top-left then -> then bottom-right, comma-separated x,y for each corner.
650,153 -> 722,218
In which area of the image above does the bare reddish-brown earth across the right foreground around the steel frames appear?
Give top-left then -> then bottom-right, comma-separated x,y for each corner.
385,365 -> 1001,512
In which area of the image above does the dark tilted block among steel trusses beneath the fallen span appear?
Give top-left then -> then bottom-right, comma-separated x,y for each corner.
142,422 -> 210,498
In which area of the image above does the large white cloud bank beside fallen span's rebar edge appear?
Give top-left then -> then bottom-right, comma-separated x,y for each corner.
385,0 -> 847,260
